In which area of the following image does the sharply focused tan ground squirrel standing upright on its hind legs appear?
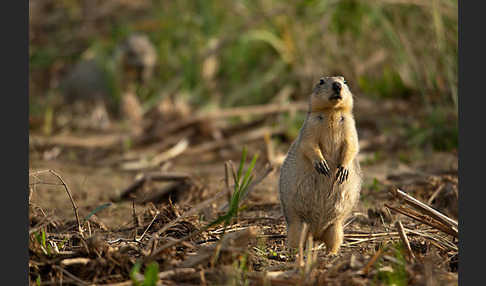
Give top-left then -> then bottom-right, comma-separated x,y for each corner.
279,76 -> 362,254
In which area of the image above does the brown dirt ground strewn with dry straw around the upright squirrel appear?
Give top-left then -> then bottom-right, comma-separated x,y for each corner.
29,95 -> 458,285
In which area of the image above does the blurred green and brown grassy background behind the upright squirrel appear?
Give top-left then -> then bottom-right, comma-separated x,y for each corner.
29,0 -> 458,155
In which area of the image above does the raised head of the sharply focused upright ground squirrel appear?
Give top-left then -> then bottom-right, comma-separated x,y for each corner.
310,76 -> 353,111
